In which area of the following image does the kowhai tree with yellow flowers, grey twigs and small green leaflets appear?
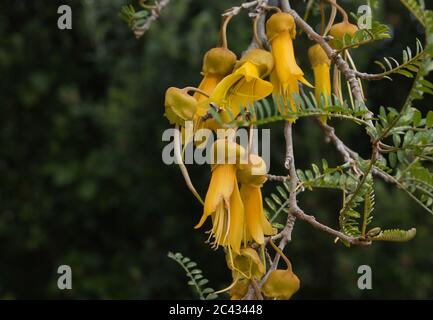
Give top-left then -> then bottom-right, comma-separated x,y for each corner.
122,0 -> 433,299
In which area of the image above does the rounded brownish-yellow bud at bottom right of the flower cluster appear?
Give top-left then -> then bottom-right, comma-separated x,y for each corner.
262,269 -> 300,300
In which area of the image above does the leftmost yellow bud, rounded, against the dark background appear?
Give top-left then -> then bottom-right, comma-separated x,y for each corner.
164,87 -> 197,126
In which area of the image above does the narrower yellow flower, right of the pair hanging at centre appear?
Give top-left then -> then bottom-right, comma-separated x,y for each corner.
237,154 -> 275,245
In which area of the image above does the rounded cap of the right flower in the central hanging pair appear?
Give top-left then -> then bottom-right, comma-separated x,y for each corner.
237,154 -> 267,187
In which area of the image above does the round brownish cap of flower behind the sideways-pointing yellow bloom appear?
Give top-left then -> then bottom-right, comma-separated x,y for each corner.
203,47 -> 236,76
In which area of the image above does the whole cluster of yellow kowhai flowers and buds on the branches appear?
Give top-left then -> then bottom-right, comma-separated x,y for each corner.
165,12 -> 356,299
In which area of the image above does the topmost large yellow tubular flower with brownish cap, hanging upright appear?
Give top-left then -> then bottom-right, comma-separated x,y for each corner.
266,12 -> 312,117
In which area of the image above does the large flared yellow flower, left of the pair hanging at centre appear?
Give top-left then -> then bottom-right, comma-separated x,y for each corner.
195,139 -> 245,254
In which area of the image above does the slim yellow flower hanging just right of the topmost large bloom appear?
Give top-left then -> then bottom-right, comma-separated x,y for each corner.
308,44 -> 331,123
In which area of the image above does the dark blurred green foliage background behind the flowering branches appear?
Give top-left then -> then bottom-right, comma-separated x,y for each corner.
0,0 -> 433,299
